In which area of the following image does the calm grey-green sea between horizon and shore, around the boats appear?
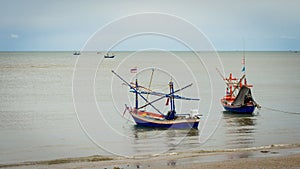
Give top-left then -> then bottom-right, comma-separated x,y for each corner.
0,51 -> 300,164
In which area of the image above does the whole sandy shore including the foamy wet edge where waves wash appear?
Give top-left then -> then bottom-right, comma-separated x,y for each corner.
0,146 -> 300,169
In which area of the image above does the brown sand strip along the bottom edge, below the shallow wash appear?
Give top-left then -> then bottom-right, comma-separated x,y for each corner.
4,154 -> 300,169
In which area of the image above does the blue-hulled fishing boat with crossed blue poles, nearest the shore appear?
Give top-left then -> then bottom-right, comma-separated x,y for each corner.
112,70 -> 201,129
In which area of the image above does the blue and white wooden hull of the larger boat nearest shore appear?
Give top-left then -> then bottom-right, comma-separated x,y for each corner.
130,113 -> 200,129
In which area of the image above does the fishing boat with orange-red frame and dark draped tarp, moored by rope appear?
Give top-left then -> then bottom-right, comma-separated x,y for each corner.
217,58 -> 260,114
